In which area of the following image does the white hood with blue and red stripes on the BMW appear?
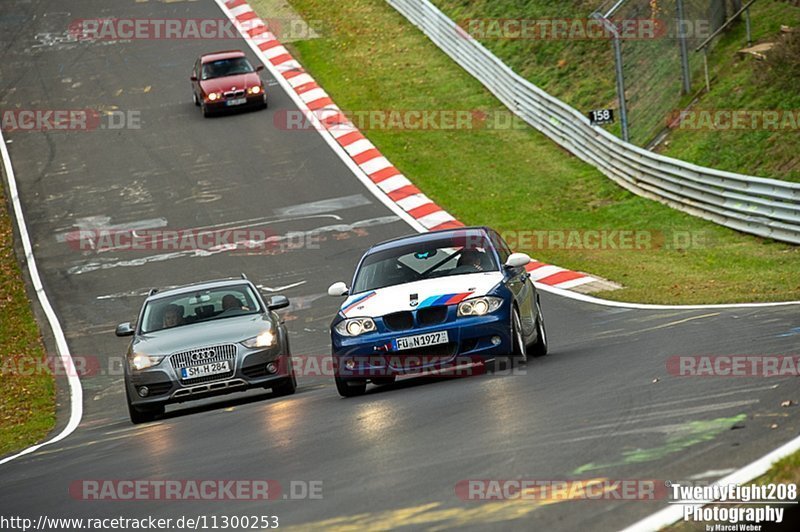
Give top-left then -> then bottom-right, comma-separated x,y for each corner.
339,272 -> 503,318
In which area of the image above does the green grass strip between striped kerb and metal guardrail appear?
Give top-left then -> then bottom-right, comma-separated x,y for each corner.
253,0 -> 800,304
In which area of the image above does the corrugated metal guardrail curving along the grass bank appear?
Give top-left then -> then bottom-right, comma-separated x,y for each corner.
387,0 -> 800,244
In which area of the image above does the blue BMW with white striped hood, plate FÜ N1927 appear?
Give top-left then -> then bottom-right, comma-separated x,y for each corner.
328,227 -> 547,397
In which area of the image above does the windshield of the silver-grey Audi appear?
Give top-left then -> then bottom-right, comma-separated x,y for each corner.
141,284 -> 261,333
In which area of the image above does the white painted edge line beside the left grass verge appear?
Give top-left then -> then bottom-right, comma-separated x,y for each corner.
0,131 -> 83,465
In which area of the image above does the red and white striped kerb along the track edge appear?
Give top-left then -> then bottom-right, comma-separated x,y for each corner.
224,0 -> 618,292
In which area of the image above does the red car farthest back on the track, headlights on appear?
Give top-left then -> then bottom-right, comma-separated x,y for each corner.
190,50 -> 267,116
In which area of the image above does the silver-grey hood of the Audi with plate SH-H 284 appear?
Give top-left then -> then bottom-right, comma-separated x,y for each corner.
131,314 -> 277,355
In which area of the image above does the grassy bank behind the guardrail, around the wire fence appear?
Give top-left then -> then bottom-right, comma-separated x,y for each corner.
433,0 -> 800,182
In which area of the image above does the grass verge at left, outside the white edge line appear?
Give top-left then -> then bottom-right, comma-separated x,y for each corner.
0,187 -> 55,456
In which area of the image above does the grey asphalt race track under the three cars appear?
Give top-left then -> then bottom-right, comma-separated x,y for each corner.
0,0 -> 800,530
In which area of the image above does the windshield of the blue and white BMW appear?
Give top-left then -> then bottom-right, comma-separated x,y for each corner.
351,238 -> 499,294
